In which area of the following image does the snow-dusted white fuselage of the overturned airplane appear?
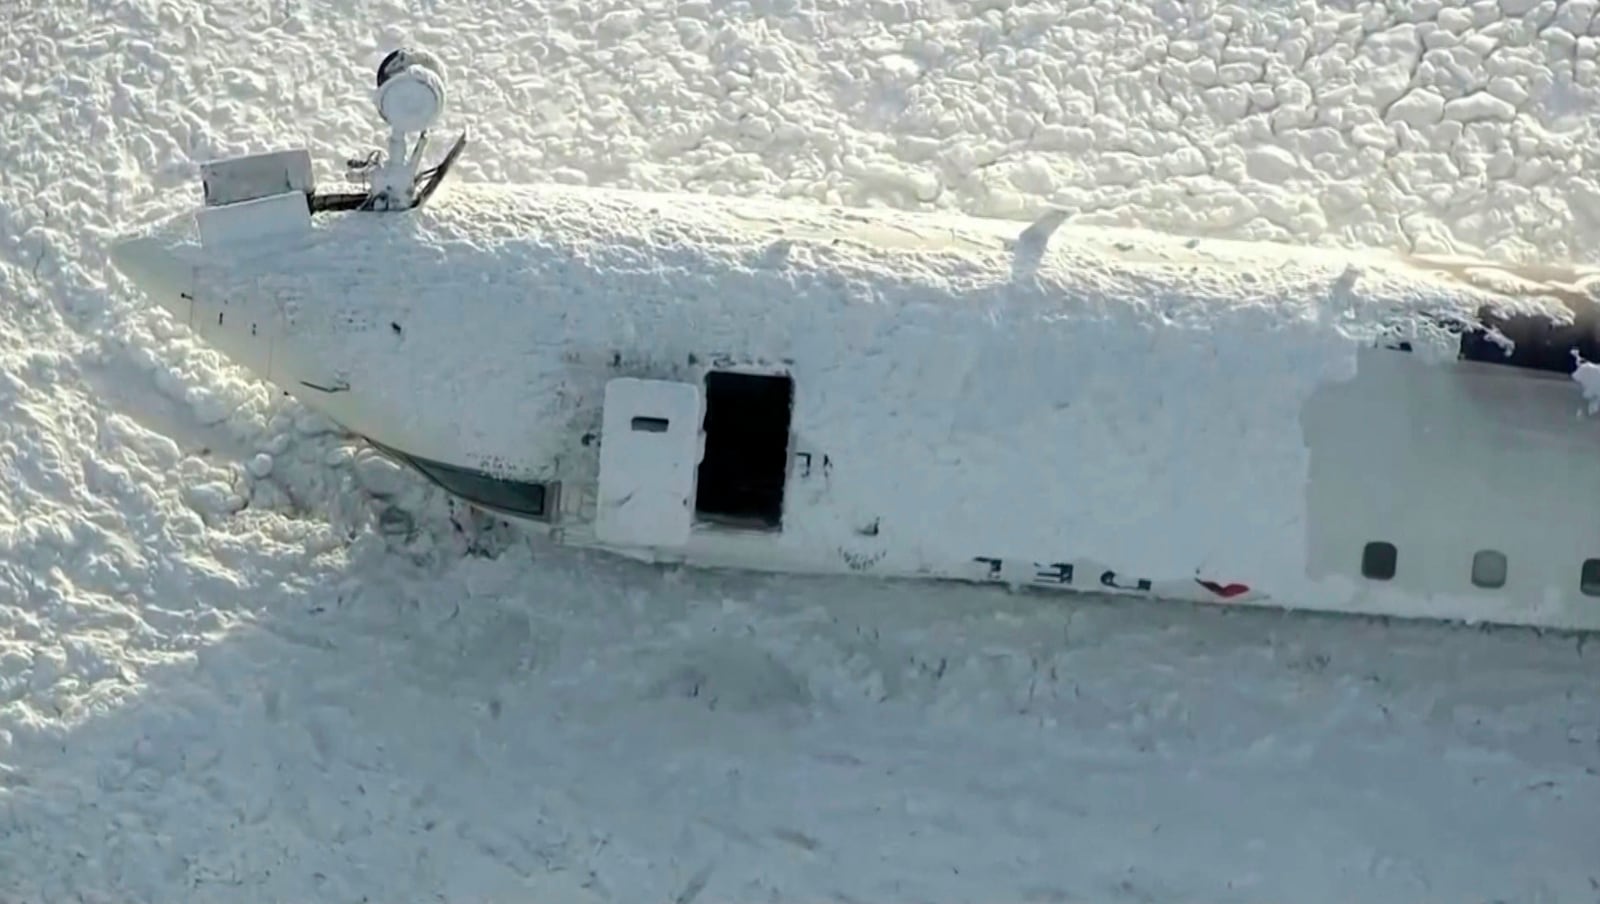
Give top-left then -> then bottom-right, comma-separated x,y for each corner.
106,186 -> 1600,626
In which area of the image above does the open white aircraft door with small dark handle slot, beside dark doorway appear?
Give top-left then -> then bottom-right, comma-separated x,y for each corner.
595,378 -> 704,547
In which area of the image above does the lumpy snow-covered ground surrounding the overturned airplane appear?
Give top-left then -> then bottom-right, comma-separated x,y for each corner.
0,0 -> 1600,904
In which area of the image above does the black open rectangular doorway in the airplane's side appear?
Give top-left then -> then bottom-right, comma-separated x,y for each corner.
694,371 -> 795,530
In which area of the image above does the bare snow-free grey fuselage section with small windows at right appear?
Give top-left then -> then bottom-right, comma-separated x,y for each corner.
1288,349 -> 1600,626
